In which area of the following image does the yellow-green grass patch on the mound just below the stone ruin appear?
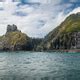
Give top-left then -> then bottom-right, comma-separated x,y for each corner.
4,31 -> 29,46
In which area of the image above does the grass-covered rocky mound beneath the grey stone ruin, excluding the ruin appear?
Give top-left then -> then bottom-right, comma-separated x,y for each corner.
0,31 -> 29,50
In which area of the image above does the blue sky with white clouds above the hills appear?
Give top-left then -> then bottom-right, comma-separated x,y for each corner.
0,0 -> 80,38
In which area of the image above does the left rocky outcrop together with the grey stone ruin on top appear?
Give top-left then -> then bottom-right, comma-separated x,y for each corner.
0,24 -> 30,51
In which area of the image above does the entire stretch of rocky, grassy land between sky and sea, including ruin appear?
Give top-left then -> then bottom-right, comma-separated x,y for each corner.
0,13 -> 80,51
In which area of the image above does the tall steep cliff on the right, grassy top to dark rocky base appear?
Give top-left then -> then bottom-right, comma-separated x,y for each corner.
37,13 -> 80,50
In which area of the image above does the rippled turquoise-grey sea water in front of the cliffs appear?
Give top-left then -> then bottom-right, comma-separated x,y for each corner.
0,52 -> 80,80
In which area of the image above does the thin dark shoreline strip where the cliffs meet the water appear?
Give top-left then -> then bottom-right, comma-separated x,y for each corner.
0,49 -> 80,53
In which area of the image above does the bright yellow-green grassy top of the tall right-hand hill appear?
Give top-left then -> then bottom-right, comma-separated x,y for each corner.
60,13 -> 80,33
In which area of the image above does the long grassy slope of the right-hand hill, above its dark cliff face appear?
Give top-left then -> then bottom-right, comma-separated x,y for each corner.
38,13 -> 80,50
